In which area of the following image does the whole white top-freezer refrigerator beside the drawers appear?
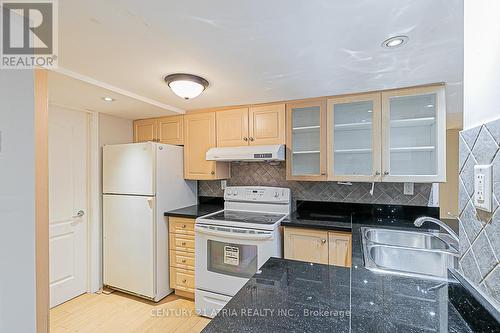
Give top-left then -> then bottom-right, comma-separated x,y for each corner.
102,142 -> 197,301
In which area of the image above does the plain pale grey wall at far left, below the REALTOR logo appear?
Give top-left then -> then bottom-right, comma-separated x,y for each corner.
0,69 -> 35,332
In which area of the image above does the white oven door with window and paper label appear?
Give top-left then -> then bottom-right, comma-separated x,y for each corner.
195,224 -> 279,296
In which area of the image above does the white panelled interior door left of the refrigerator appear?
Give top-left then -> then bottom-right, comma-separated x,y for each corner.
49,108 -> 88,307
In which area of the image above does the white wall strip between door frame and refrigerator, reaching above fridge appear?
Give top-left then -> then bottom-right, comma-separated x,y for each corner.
94,113 -> 134,287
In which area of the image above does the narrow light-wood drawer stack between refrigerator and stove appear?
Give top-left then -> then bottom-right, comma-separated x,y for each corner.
168,217 -> 195,298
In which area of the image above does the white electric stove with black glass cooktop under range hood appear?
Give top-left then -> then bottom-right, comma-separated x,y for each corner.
195,186 -> 291,318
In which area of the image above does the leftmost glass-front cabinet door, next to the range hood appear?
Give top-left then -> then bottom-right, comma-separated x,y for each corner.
286,99 -> 327,181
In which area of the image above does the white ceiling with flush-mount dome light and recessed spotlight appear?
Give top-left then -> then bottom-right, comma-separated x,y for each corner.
59,0 -> 463,127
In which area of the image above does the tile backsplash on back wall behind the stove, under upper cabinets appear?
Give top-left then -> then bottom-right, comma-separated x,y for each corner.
198,162 -> 437,207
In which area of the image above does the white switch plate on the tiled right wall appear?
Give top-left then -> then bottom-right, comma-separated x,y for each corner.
474,164 -> 493,213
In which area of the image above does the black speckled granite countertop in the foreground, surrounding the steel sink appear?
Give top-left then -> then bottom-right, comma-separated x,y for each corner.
203,201 -> 499,333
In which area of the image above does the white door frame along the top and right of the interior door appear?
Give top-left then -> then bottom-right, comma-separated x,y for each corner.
49,103 -> 102,293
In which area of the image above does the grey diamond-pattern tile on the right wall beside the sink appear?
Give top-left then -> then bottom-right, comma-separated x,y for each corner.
458,119 -> 500,307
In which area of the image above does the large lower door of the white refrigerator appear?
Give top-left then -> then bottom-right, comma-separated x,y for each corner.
103,195 -> 156,298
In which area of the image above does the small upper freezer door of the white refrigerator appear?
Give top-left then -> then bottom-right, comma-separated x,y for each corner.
102,142 -> 156,195
